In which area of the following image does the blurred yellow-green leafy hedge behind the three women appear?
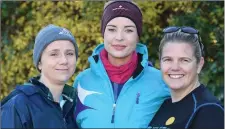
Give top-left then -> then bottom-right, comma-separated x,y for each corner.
0,0 -> 224,102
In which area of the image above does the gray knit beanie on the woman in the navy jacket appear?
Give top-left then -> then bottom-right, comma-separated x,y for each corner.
33,24 -> 78,71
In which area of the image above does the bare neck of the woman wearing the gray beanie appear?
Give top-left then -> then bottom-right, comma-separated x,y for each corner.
39,75 -> 65,102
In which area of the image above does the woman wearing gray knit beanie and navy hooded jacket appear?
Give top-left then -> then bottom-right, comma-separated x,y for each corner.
1,24 -> 78,128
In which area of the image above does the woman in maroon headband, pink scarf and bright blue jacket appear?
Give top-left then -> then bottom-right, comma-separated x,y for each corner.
74,0 -> 169,128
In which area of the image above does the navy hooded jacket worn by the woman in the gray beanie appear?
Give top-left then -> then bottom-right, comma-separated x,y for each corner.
1,78 -> 77,129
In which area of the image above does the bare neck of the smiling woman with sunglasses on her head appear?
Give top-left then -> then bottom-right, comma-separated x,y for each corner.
171,79 -> 200,103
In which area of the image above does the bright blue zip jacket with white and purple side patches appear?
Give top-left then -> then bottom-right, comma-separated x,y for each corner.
73,43 -> 169,128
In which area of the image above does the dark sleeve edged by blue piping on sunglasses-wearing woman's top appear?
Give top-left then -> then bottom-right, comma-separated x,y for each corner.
190,105 -> 224,129
